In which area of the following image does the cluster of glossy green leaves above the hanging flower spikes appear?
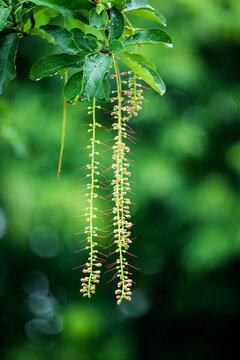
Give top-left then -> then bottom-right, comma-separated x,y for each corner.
0,0 -> 172,98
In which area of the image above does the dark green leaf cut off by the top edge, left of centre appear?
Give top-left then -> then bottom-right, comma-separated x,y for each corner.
25,0 -> 94,19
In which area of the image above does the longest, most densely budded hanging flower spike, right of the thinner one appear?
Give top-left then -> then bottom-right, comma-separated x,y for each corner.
109,54 -> 137,305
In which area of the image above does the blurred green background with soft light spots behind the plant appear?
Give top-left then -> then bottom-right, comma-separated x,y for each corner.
0,0 -> 240,360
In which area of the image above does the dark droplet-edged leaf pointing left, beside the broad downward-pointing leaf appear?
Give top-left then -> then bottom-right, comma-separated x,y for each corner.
30,54 -> 84,80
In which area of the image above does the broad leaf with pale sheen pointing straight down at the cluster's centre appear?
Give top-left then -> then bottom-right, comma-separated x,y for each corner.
82,52 -> 112,100
